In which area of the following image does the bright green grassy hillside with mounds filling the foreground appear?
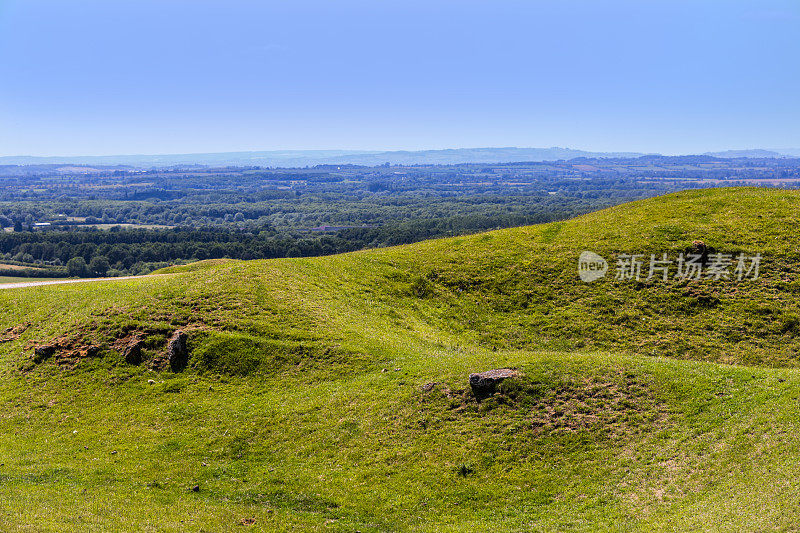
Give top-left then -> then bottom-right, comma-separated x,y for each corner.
0,189 -> 800,531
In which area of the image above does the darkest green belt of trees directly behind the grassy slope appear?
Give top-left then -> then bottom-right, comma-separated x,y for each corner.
0,212 -> 564,277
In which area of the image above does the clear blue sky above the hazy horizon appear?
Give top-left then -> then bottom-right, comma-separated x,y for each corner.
0,0 -> 800,155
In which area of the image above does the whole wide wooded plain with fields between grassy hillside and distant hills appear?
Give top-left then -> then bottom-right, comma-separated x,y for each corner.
0,156 -> 800,277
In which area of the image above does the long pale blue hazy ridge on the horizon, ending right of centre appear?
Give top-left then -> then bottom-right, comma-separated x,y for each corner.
0,147 -> 643,167
